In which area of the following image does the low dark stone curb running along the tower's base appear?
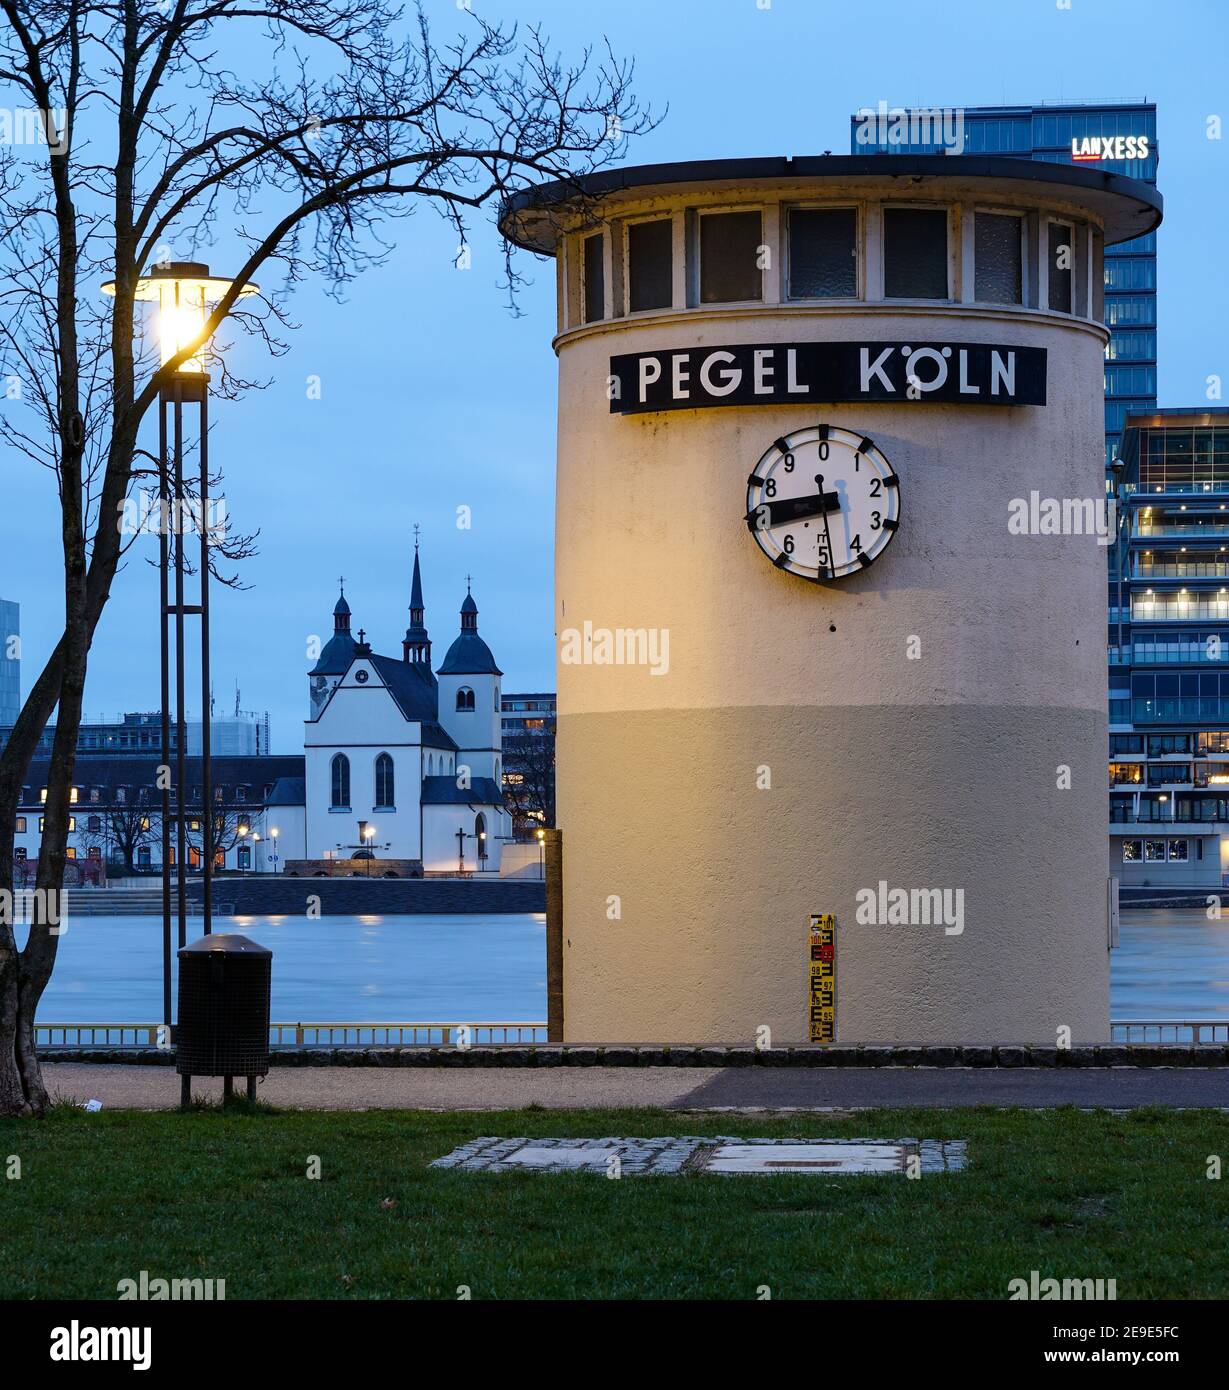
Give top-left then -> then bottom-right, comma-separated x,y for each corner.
40,1043 -> 1229,1068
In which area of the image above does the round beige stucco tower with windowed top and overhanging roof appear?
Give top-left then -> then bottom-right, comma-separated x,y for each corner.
502,156 -> 1161,1045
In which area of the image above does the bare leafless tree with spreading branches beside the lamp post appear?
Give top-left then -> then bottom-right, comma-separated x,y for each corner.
0,0 -> 652,1113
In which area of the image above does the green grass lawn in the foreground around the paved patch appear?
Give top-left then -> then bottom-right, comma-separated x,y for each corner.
0,1106 -> 1229,1300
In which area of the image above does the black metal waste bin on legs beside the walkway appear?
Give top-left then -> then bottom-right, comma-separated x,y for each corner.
175,933 -> 272,1105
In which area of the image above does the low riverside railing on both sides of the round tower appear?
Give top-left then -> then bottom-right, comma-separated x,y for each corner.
35,1019 -> 1229,1052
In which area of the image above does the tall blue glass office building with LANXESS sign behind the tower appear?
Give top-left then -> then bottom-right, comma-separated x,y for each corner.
849,101 -> 1158,467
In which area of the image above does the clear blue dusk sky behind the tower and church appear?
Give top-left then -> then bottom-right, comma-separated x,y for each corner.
0,0 -> 1229,752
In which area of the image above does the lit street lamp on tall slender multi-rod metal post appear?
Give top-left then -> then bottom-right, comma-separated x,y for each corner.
101,261 -> 259,1029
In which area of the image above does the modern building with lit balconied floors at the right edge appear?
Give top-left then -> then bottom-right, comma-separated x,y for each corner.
1109,406 -> 1229,887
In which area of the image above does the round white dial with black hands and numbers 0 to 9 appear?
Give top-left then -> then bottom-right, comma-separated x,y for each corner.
747,425 -> 901,581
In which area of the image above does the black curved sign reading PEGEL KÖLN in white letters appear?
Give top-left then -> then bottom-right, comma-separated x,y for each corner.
608,342 -> 1045,414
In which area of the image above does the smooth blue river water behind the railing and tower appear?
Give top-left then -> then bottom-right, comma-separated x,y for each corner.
18,912 -> 1229,1023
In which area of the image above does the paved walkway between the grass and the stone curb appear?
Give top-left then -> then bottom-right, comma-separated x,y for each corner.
43,1062 -> 1229,1111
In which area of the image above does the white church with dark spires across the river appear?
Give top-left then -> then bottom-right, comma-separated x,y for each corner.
293,543 -> 512,876
